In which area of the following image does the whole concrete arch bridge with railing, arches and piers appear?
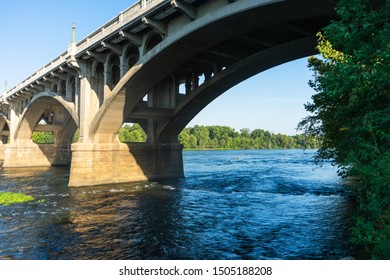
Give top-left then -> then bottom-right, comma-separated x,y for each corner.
0,0 -> 337,186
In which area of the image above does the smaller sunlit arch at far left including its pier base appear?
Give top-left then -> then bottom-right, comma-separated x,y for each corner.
3,92 -> 78,167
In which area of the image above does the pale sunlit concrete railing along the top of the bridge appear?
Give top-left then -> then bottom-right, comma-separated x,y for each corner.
0,0 -> 165,101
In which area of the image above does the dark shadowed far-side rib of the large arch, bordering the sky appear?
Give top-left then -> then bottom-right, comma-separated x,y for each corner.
158,37 -> 317,143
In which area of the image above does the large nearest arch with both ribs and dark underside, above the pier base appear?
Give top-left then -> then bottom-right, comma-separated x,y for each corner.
90,0 -> 337,143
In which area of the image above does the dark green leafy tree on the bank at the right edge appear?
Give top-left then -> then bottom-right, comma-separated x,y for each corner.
299,0 -> 390,258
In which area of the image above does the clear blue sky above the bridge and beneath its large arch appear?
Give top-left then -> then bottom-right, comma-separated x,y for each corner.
0,0 -> 314,135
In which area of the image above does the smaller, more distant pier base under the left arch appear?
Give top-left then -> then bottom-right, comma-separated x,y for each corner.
3,143 -> 71,167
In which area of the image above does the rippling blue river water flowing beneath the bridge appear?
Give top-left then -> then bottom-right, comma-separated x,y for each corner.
0,150 -> 352,259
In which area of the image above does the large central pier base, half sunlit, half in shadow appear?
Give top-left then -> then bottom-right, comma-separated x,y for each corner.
69,143 -> 184,187
